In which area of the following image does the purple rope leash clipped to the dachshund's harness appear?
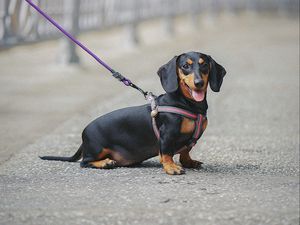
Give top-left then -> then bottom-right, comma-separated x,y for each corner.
25,0 -> 148,97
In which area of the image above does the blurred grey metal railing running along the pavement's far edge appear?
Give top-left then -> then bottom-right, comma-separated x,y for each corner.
0,0 -> 299,61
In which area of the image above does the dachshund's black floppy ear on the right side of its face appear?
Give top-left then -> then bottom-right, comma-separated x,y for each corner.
208,56 -> 226,92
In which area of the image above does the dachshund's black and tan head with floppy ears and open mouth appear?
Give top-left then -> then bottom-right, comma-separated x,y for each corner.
157,52 -> 226,102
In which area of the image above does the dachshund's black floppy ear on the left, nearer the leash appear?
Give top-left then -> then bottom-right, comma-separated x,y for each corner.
157,56 -> 178,93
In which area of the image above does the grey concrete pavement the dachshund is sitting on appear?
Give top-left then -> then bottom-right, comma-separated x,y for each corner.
0,16 -> 299,225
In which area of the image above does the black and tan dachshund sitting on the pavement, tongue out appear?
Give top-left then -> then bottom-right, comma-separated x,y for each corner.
41,52 -> 226,175
